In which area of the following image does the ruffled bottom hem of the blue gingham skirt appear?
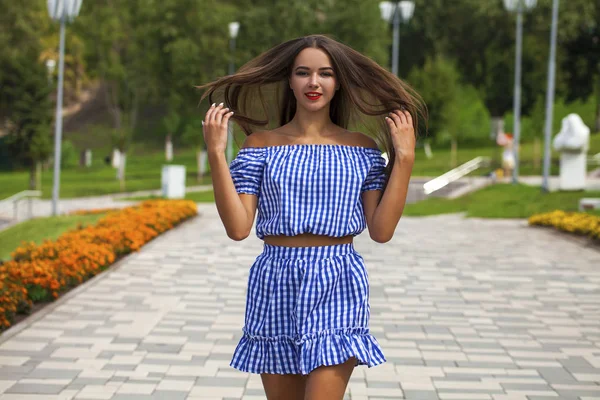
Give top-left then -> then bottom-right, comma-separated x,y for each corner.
230,328 -> 385,375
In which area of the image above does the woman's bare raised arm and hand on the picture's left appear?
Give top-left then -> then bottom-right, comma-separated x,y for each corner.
202,103 -> 258,240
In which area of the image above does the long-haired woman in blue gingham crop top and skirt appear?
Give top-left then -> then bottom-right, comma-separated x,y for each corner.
201,35 -> 425,400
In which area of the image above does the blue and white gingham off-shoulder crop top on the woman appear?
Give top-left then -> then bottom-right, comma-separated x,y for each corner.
229,144 -> 386,239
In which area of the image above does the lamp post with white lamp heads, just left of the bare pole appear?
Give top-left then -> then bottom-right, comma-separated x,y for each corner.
504,0 -> 537,183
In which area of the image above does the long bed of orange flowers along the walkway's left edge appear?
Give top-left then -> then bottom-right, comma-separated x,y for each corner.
0,200 -> 197,330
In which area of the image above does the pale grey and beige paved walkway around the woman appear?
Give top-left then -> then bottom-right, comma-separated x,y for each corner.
0,205 -> 600,400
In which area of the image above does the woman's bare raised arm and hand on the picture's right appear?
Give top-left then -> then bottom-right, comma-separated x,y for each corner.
362,110 -> 415,243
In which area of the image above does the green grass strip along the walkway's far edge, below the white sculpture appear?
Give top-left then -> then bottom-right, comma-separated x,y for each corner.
403,183 -> 600,218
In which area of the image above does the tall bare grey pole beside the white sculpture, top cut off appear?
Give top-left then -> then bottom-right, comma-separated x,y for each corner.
542,0 -> 558,192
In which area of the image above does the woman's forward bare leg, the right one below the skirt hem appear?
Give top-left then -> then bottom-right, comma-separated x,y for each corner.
304,357 -> 356,400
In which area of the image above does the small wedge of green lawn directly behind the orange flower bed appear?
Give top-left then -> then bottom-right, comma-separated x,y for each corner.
0,214 -> 104,260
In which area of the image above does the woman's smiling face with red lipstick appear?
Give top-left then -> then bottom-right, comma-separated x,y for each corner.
290,47 -> 337,111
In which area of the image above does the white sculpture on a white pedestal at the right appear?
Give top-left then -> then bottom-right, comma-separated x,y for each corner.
553,114 -> 590,190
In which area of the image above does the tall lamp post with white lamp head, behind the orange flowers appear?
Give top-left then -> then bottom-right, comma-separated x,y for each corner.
48,0 -> 82,215
